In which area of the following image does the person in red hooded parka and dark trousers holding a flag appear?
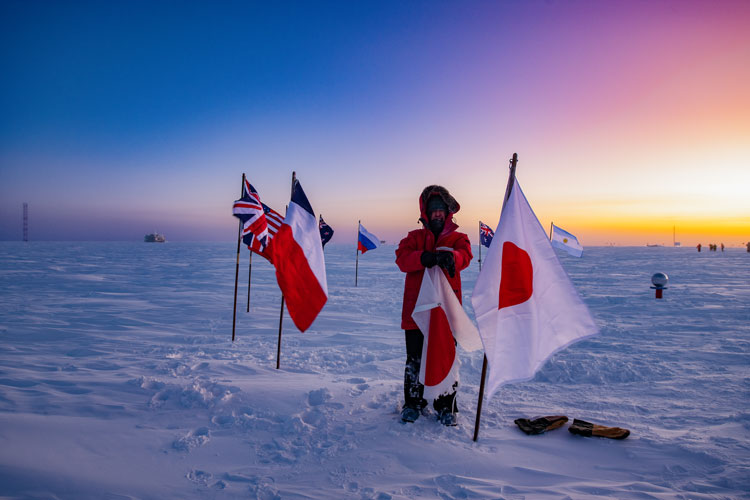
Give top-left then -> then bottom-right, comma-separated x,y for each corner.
396,185 -> 473,426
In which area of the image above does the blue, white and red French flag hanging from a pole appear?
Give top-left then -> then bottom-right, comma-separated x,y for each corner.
271,179 -> 328,332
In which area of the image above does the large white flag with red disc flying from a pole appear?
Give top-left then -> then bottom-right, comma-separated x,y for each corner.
471,180 -> 598,396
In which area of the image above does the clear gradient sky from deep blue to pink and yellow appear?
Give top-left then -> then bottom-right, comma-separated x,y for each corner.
0,0 -> 750,246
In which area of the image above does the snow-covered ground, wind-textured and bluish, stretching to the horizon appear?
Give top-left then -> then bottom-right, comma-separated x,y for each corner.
0,242 -> 750,499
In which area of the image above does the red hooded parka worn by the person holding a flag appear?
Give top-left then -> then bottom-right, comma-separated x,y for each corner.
396,186 -> 473,330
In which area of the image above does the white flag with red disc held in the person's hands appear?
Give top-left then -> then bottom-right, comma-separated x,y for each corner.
412,267 -> 482,400
